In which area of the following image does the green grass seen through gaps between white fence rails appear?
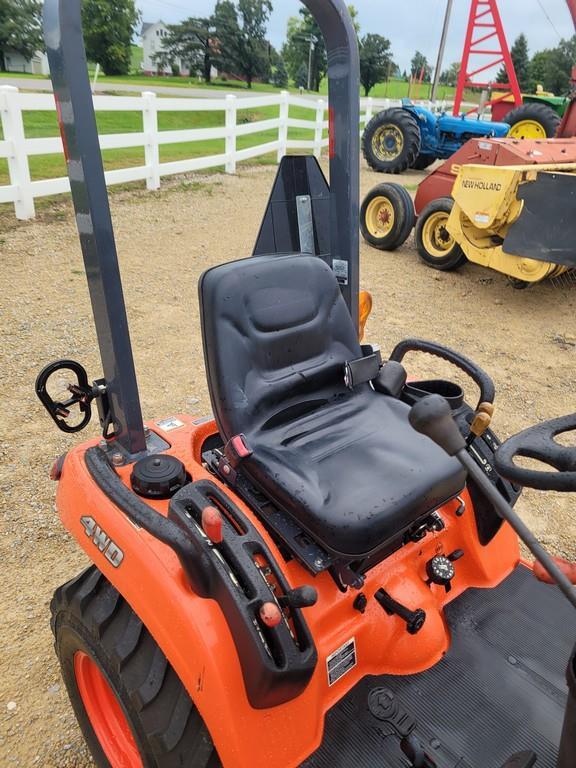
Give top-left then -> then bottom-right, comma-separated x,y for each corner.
0,100 -> 326,185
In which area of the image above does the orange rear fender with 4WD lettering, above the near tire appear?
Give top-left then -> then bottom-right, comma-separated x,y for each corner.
56,443 -> 323,768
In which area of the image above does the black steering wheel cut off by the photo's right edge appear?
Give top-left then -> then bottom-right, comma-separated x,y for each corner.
495,413 -> 576,493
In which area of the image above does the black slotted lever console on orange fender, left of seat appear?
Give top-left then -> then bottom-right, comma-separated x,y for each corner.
169,480 -> 317,709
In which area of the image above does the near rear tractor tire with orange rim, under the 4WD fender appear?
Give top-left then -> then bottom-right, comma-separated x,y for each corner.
50,566 -> 221,768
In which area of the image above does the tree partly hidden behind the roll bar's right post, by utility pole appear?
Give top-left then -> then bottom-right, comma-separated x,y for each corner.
282,5 -> 359,91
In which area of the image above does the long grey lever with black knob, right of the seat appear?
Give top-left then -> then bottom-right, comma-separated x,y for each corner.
410,395 -> 576,608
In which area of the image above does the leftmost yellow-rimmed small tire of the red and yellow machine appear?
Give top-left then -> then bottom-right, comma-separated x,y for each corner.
360,184 -> 416,251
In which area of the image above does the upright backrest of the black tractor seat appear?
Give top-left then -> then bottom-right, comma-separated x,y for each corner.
199,255 -> 362,439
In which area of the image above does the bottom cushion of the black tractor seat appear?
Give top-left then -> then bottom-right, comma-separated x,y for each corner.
242,388 -> 465,559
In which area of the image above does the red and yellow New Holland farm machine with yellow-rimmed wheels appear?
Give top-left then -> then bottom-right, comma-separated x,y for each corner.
360,139 -> 576,288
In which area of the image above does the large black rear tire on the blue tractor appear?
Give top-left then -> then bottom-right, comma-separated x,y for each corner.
362,107 -> 422,173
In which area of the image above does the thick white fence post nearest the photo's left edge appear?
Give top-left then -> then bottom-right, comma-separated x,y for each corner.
0,85 -> 35,220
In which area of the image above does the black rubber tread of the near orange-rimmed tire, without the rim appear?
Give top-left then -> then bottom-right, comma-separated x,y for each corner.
50,566 -> 221,768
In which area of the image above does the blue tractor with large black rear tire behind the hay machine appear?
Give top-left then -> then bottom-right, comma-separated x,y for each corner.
363,99 -> 510,173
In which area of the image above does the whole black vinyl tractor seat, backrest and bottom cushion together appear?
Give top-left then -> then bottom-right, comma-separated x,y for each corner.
200,255 -> 465,561
